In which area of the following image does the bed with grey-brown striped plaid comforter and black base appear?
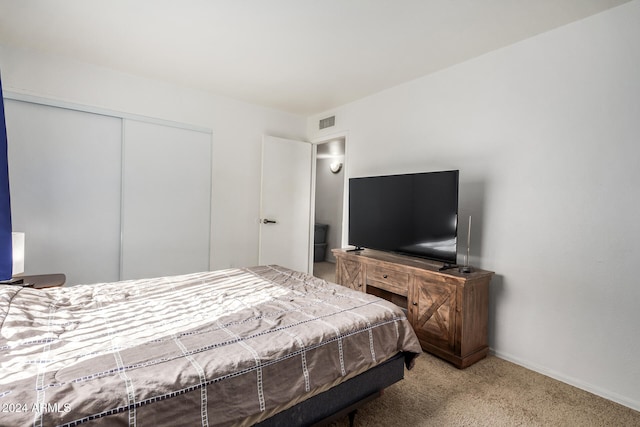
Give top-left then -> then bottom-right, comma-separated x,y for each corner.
0,265 -> 421,426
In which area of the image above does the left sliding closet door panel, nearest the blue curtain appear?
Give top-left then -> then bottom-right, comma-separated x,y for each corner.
5,99 -> 122,284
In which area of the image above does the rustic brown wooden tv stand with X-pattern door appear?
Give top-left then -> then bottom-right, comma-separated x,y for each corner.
332,249 -> 494,369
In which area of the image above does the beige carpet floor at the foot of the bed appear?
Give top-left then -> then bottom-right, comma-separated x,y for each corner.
331,353 -> 640,427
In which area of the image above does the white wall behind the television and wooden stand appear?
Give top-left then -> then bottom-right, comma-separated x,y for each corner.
308,0 -> 640,409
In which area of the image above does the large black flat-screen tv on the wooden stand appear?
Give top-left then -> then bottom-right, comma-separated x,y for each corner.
349,170 -> 458,264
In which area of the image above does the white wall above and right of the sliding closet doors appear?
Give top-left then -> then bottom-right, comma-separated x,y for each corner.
0,45 -> 305,269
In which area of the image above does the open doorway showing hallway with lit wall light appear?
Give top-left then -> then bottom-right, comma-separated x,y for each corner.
313,136 -> 346,282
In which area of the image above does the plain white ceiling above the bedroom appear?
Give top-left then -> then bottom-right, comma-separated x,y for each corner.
0,0 -> 629,115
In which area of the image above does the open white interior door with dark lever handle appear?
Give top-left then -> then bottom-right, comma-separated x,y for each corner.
258,136 -> 313,272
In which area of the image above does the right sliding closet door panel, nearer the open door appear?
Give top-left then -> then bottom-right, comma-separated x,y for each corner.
121,120 -> 211,279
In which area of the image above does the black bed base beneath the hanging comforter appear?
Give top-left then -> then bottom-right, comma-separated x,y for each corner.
256,353 -> 405,427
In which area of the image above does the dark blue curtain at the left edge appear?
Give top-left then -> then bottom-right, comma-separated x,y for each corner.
0,73 -> 13,280
